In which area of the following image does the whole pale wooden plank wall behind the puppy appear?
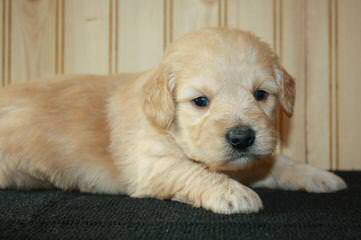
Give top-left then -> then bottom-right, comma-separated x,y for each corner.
0,0 -> 361,169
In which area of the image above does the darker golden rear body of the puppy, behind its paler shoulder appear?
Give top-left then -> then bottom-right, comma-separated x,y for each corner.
0,74 -> 118,192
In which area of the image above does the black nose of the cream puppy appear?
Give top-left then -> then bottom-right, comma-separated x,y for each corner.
226,127 -> 256,151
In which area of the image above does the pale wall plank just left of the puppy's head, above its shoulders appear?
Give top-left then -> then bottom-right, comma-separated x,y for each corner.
116,0 -> 165,72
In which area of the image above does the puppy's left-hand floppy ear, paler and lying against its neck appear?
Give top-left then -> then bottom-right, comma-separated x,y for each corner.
144,67 -> 175,129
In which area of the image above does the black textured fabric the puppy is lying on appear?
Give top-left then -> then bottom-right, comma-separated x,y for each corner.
0,172 -> 361,240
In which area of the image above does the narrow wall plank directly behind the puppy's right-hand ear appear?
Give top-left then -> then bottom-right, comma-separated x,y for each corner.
280,0 -> 307,162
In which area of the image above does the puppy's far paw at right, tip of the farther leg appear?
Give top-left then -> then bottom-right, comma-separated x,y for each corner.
305,169 -> 347,193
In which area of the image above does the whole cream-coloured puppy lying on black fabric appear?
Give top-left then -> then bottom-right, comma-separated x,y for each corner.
0,29 -> 346,214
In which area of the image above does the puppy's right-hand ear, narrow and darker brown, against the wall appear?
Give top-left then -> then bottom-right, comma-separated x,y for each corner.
274,65 -> 296,117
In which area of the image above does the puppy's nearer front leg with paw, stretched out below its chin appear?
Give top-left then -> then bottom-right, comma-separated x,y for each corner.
131,158 -> 262,214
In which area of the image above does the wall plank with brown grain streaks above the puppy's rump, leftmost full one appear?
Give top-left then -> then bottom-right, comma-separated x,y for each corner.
11,0 -> 55,81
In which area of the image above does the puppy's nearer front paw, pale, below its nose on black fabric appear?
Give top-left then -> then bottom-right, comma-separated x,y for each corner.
201,180 -> 263,214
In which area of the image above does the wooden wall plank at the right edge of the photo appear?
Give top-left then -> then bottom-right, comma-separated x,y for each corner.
336,0 -> 361,169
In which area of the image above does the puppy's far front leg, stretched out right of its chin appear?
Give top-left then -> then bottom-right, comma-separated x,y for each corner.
253,156 -> 347,193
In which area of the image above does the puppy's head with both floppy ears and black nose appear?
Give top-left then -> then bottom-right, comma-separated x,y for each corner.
145,29 -> 295,170
